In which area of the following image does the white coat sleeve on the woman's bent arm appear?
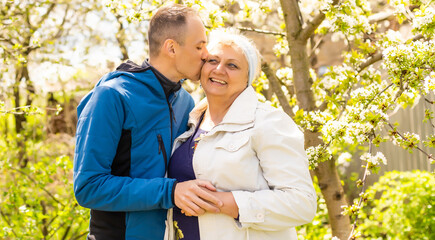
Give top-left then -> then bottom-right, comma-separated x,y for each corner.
232,111 -> 317,231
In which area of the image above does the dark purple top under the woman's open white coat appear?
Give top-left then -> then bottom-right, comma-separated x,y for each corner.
168,118 -> 206,240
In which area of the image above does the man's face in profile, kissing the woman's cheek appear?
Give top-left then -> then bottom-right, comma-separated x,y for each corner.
175,16 -> 208,81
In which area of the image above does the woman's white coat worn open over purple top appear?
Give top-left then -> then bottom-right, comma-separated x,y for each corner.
166,87 -> 317,240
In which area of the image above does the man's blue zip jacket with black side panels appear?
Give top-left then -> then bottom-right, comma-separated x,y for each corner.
74,62 -> 194,240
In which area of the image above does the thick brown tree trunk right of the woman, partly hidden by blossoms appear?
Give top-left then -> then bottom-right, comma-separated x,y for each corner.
280,0 -> 351,240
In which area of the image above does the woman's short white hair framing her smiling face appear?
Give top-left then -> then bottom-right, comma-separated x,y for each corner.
207,28 -> 261,85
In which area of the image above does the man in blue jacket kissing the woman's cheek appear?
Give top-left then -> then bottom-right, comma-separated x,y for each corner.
74,5 -> 222,240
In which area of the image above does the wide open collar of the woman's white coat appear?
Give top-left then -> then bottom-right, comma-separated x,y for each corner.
189,86 -> 258,134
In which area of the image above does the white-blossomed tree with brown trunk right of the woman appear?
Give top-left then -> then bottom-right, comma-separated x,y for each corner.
274,1 -> 435,239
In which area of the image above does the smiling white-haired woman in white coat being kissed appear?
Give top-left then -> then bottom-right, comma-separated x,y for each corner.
168,30 -> 316,240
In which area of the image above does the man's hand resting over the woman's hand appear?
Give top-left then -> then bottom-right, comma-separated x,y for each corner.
174,179 -> 223,216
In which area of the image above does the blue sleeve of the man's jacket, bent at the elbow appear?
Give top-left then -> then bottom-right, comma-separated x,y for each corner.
74,86 -> 175,211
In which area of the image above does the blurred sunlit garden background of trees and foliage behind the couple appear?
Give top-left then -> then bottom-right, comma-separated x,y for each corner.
0,0 -> 435,239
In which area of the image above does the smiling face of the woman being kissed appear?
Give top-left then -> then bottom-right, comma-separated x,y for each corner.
200,45 -> 249,103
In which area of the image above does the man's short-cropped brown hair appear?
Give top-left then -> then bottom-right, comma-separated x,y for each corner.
148,4 -> 198,56
